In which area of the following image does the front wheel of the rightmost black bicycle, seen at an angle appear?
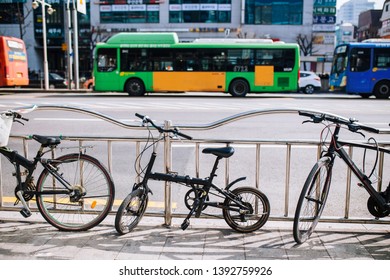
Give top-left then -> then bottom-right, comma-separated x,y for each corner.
293,157 -> 332,244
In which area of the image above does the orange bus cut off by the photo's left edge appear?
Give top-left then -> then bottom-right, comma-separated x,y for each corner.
0,36 -> 29,87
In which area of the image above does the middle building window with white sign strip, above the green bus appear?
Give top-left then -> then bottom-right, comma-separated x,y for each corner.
169,0 -> 232,23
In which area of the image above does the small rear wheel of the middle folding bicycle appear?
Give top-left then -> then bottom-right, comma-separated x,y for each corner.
222,187 -> 270,233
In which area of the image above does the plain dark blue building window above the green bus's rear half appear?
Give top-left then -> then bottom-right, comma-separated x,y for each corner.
245,0 -> 303,25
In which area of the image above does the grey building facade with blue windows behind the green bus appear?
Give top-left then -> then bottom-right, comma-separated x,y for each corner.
0,0 -> 336,81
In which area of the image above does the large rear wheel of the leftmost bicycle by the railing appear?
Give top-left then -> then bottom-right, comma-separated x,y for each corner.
36,154 -> 115,231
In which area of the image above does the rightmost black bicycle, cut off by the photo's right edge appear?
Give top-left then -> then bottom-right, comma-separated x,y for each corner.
293,111 -> 390,244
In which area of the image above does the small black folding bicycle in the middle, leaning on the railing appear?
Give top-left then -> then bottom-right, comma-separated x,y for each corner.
115,114 -> 270,234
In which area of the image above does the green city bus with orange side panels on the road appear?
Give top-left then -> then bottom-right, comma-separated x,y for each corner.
93,33 -> 300,96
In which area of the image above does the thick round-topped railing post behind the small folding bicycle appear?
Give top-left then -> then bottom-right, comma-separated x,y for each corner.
164,120 -> 172,226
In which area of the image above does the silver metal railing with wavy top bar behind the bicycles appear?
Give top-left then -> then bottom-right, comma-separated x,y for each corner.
0,106 -> 390,225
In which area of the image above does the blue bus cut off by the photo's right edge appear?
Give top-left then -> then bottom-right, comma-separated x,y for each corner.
329,40 -> 390,99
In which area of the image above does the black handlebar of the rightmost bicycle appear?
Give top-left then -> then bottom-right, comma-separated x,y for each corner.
299,111 -> 380,134
